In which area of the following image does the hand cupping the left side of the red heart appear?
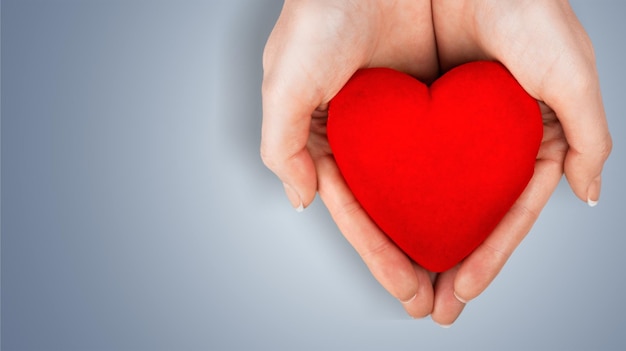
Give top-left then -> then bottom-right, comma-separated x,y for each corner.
261,0 -> 438,317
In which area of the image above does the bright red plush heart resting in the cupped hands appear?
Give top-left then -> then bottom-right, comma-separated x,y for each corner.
327,61 -> 543,272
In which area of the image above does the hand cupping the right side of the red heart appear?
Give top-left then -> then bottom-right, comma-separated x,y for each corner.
432,0 -> 612,324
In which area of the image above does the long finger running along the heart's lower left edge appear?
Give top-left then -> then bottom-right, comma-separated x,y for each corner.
316,156 -> 432,317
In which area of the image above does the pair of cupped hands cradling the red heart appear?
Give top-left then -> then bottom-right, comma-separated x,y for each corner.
261,0 -> 612,326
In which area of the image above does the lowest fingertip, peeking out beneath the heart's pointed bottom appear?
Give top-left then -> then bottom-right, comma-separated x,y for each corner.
431,265 -> 465,328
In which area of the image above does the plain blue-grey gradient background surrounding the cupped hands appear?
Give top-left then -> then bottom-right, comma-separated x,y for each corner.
1,0 -> 626,351
